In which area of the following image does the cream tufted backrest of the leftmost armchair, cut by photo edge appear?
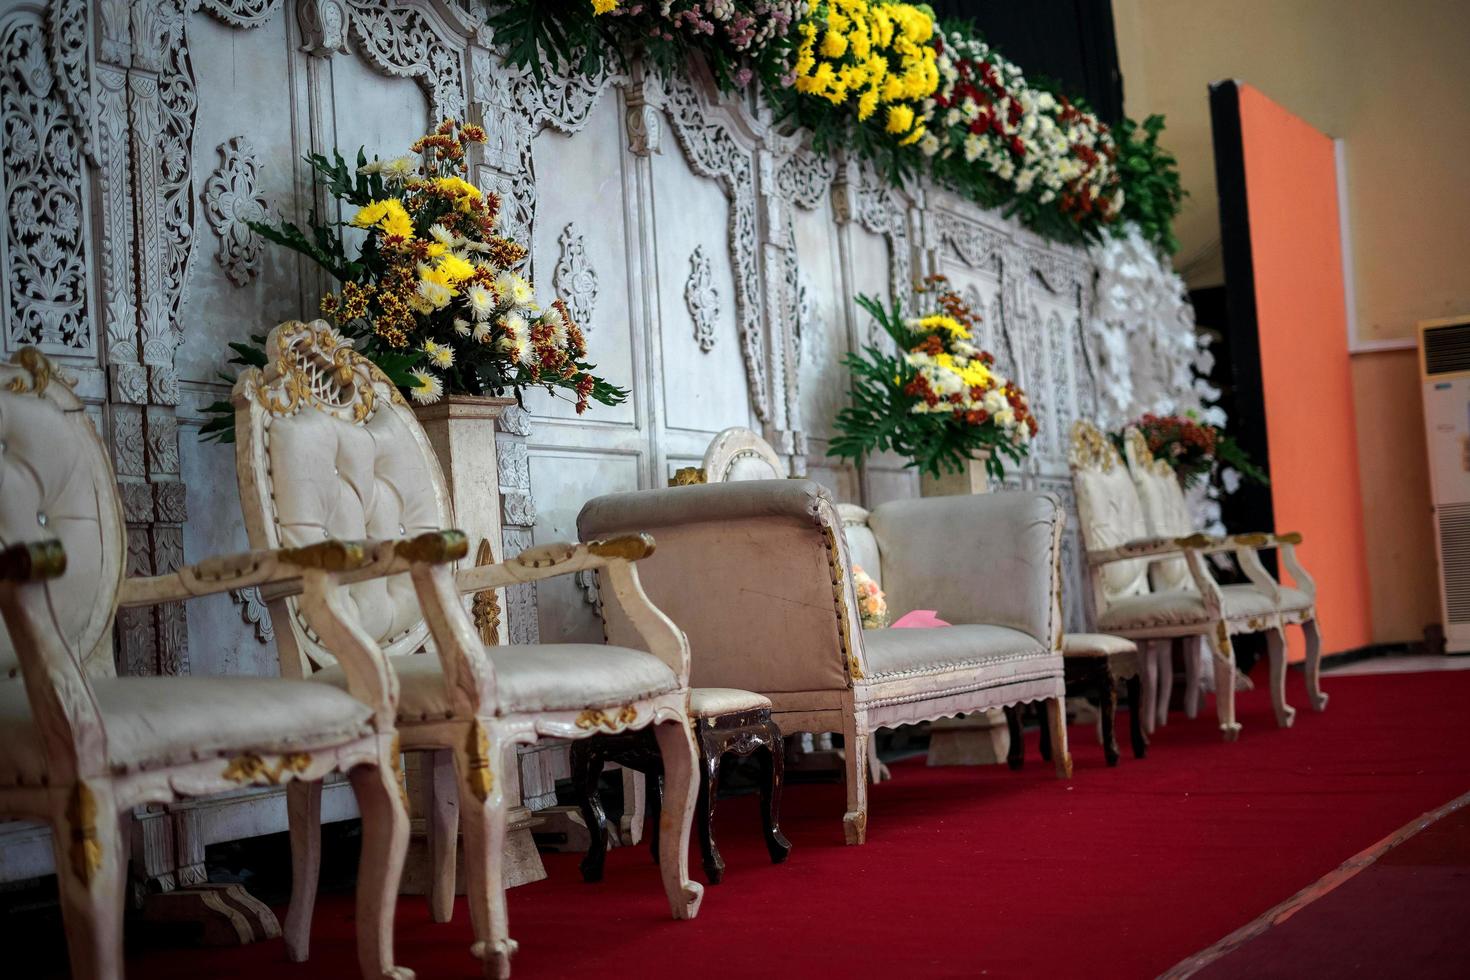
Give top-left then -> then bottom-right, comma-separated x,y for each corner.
0,348 -> 126,683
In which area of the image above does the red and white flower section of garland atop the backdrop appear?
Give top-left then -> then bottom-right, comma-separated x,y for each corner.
919,28 -> 1125,237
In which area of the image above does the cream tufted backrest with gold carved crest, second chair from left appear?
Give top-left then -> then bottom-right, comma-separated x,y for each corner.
234,320 -> 454,667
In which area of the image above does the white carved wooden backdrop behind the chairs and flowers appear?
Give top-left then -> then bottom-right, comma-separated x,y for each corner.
0,0 -> 1197,840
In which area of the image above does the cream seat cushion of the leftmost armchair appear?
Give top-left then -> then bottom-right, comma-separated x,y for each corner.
0,677 -> 373,786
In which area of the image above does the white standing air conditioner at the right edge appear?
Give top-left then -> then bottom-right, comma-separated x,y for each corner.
1419,316 -> 1470,654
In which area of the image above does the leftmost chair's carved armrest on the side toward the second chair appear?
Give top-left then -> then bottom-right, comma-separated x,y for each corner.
118,539 -> 375,608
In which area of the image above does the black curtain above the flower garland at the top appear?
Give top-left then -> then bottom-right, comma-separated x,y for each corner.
929,0 -> 1123,123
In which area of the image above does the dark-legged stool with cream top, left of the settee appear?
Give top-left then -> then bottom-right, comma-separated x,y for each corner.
570,688 -> 791,884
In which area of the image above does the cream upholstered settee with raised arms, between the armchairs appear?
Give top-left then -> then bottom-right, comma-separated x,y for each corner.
578,480 -> 1072,843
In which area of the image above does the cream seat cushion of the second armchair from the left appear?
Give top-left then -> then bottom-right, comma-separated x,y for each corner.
312,644 -> 679,723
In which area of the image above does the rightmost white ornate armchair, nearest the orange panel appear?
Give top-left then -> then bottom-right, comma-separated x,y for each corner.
1123,428 -> 1327,723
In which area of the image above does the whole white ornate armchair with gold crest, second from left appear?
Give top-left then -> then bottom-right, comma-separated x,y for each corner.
234,320 -> 703,977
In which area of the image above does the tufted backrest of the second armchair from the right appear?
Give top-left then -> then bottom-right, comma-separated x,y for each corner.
1067,419 -> 1150,613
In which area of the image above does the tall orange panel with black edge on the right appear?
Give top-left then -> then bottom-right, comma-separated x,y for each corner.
1239,85 -> 1373,657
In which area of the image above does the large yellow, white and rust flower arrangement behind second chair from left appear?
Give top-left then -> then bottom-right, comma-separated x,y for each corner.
200,119 -> 628,442
